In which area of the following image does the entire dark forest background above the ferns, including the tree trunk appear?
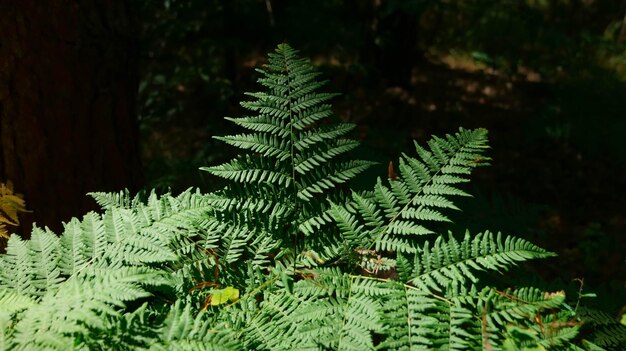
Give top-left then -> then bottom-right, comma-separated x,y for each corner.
0,0 -> 626,314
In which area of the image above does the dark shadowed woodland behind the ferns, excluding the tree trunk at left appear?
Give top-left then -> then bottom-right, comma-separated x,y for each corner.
139,0 -> 626,313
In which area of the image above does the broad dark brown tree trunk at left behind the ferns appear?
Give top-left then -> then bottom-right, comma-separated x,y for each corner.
0,0 -> 142,236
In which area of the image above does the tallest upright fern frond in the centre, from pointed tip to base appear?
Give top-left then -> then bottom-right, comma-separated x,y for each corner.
195,44 -> 373,294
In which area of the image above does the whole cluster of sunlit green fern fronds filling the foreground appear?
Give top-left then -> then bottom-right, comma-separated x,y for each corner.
0,44 -> 626,351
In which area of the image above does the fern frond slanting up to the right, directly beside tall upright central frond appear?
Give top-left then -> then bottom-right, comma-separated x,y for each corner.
334,129 -> 488,253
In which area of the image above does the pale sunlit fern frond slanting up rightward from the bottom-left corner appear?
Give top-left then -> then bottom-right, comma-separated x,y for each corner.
14,269 -> 162,350
